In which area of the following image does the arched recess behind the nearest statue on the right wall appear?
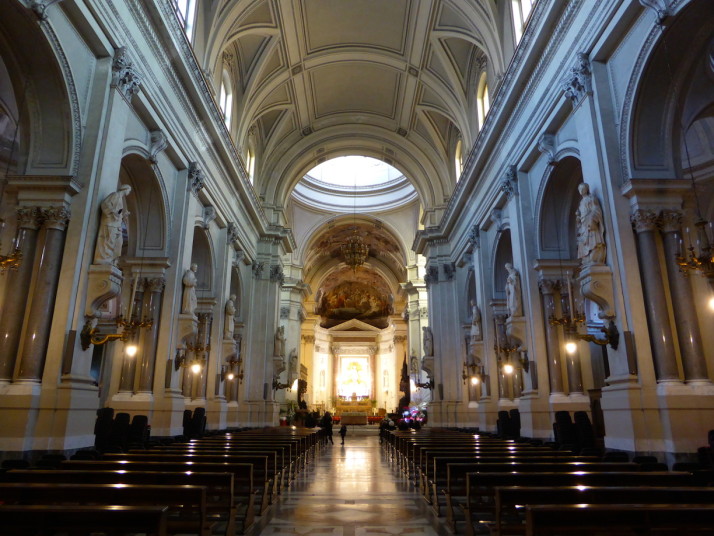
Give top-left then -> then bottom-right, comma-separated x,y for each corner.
538,156 -> 583,259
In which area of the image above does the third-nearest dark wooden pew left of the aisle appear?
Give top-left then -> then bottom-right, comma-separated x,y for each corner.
0,469 -> 239,536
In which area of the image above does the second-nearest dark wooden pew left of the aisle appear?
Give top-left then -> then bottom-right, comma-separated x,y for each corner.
0,482 -> 213,536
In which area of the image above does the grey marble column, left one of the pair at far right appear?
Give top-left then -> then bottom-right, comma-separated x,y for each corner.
631,209 -> 679,381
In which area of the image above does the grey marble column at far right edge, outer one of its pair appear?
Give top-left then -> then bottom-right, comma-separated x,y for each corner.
660,210 -> 708,381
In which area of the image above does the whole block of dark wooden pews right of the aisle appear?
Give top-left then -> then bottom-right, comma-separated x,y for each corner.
382,428 -> 714,536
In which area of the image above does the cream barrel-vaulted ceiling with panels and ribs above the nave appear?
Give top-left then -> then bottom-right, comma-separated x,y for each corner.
204,0 -> 503,211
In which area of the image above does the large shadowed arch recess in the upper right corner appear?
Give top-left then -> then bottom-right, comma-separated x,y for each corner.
623,0 -> 714,178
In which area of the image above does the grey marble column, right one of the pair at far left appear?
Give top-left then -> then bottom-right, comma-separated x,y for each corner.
17,206 -> 70,382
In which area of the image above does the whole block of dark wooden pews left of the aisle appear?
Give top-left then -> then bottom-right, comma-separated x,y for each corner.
0,427 -> 324,536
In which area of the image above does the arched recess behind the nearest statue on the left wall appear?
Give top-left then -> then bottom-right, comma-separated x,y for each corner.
119,154 -> 167,257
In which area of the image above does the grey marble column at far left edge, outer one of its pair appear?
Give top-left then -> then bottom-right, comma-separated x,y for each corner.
0,207 -> 40,382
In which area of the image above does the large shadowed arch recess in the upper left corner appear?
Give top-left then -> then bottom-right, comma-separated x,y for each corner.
0,0 -> 80,175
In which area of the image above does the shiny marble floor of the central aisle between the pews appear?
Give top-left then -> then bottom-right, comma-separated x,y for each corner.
250,434 -> 450,536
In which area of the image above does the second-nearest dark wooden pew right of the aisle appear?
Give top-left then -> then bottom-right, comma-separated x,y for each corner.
490,486 -> 714,536
